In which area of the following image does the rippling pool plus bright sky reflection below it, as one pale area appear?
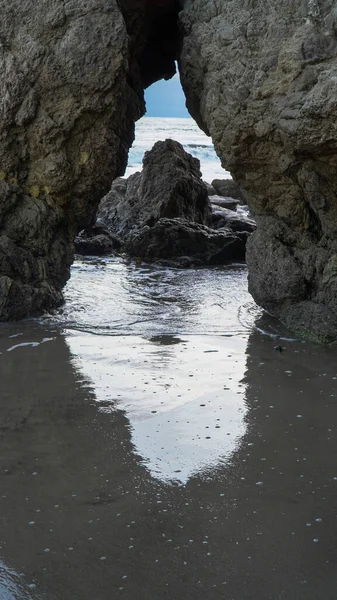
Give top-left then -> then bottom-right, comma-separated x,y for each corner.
42,258 -> 261,483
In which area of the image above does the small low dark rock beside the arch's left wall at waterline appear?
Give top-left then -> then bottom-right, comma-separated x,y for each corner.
75,224 -> 122,256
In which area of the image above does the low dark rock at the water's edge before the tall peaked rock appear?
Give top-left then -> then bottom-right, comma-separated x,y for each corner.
126,218 -> 248,265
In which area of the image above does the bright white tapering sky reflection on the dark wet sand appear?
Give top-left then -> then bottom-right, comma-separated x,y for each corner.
66,332 -> 247,483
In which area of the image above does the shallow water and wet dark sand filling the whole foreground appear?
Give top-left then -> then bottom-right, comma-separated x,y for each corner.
0,259 -> 337,600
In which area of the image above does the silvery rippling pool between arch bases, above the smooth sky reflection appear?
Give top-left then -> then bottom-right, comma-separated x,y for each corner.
50,259 -> 261,336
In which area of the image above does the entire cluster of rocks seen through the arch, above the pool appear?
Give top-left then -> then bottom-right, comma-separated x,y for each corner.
75,139 -> 255,267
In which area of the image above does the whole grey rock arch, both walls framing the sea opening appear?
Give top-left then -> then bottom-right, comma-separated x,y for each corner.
0,0 -> 337,340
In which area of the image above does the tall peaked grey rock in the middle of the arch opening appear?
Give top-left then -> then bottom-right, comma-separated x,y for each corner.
97,140 -> 211,239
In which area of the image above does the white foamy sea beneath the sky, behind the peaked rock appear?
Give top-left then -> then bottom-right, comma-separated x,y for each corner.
125,117 -> 231,183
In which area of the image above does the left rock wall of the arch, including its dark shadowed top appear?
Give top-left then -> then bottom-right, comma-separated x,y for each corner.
0,0 -> 178,320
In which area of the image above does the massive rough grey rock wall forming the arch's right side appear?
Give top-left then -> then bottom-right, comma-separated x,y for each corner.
180,0 -> 337,340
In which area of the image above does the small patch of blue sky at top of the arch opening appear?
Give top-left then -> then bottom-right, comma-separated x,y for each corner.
145,74 -> 190,117
